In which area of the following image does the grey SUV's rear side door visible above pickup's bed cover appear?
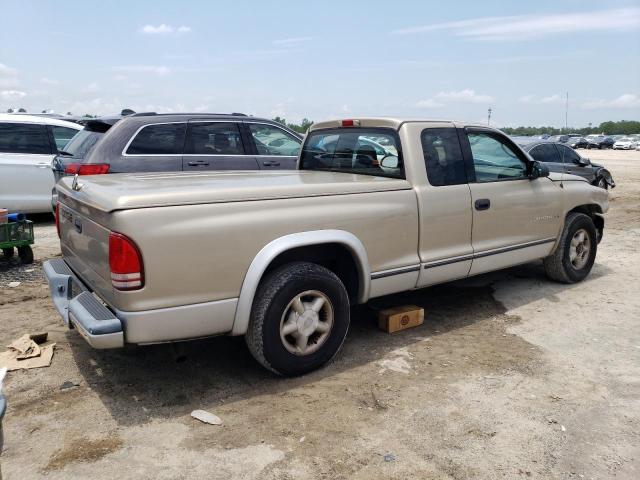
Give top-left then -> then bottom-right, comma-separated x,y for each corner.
182,120 -> 259,171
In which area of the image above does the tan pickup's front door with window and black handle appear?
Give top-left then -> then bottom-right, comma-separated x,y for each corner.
463,128 -> 562,275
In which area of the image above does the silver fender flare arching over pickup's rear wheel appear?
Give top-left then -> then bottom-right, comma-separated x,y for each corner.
231,230 -> 371,335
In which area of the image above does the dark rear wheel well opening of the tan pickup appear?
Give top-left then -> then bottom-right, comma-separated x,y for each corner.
263,243 -> 360,302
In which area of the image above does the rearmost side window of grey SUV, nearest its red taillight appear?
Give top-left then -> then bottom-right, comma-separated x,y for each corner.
126,123 -> 186,155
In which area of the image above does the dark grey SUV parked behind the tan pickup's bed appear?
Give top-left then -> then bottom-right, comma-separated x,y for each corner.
58,113 -> 302,180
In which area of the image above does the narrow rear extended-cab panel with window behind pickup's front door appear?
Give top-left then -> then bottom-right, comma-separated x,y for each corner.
407,123 -> 473,287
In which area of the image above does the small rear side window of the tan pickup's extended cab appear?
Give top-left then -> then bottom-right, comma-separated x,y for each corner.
420,128 -> 467,187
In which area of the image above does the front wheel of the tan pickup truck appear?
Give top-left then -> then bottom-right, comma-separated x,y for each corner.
543,213 -> 598,283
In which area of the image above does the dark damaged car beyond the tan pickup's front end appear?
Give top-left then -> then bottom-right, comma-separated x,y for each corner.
521,141 -> 616,189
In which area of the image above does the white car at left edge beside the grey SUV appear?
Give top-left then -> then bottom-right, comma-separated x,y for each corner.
0,114 -> 82,213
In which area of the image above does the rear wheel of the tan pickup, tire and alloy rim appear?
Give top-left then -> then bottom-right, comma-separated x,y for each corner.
245,262 -> 350,376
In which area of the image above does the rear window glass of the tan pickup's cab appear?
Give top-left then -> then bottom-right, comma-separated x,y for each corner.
300,128 -> 405,178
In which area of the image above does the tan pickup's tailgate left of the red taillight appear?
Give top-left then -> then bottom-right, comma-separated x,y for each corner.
59,203 -> 113,303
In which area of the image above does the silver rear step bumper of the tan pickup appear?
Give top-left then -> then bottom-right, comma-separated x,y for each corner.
42,259 -> 124,349
